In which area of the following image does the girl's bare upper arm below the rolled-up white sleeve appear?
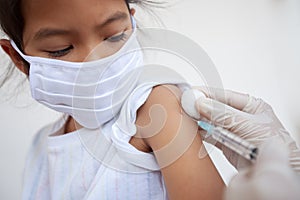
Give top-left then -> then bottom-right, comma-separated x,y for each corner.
131,85 -> 225,200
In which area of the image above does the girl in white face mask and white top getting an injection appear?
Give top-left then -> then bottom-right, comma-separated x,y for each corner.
0,0 -> 224,200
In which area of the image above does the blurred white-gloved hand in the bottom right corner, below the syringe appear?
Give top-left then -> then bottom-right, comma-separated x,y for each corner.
224,142 -> 300,200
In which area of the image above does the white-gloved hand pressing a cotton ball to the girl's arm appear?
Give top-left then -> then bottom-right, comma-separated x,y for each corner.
196,88 -> 300,174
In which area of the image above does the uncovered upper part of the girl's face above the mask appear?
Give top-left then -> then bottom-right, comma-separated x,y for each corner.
23,0 -> 134,62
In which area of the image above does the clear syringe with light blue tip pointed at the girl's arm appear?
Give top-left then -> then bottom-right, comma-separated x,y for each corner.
198,121 -> 258,162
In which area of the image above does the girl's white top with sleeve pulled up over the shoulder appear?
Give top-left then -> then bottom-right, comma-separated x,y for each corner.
22,67 -> 187,200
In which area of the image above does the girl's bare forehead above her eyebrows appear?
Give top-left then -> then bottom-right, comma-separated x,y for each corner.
22,0 -> 129,42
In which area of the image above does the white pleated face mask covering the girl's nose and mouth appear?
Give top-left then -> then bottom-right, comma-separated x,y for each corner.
11,18 -> 143,129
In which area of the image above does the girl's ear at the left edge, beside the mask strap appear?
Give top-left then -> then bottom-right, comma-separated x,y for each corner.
0,39 -> 29,76
